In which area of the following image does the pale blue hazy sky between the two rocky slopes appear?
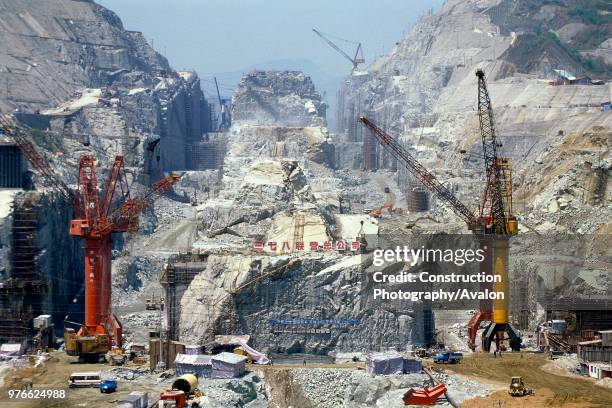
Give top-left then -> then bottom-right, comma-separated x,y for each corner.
97,0 -> 442,94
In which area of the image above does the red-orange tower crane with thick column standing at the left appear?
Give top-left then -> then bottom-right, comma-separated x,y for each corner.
65,156 -> 179,357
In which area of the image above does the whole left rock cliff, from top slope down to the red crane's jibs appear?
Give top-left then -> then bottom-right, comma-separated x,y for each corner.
0,0 -> 211,177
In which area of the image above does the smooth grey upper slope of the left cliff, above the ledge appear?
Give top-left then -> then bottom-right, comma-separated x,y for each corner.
0,0 -> 170,111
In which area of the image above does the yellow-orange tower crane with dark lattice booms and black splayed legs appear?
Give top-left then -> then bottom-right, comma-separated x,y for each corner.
359,69 -> 522,352
